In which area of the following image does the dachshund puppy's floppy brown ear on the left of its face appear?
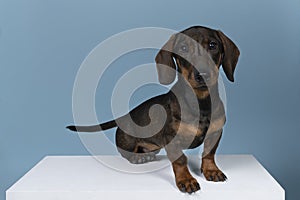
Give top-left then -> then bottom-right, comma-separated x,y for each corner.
155,34 -> 176,85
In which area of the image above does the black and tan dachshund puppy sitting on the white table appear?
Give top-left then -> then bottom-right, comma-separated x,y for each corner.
67,26 -> 240,193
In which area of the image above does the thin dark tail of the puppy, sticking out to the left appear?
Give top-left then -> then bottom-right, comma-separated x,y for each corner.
66,120 -> 117,132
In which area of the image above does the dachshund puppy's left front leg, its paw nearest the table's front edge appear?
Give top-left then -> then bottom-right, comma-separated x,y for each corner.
166,147 -> 200,194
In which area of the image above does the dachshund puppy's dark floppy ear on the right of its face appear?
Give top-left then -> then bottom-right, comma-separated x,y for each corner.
217,31 -> 240,82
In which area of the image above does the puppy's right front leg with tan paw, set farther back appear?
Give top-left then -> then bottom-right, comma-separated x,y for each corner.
201,129 -> 227,182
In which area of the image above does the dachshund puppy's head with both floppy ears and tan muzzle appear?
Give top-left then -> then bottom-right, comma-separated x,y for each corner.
155,26 -> 240,94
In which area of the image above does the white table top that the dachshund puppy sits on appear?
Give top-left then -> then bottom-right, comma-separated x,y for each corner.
6,155 -> 284,200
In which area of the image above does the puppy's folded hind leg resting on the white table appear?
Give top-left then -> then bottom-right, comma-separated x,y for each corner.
116,128 -> 160,164
